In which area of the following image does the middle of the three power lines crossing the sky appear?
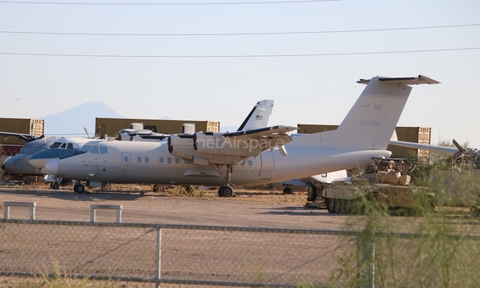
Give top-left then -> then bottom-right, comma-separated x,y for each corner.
0,23 -> 480,36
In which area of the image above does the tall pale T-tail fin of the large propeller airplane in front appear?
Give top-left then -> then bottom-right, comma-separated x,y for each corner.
331,75 -> 439,150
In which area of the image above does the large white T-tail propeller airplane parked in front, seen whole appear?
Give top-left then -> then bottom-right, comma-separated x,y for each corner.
39,75 -> 439,197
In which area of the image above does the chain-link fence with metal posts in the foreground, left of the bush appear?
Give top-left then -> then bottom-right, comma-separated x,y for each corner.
0,219 -> 356,287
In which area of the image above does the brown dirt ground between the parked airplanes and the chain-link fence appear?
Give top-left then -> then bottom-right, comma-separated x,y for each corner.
0,185 -> 356,287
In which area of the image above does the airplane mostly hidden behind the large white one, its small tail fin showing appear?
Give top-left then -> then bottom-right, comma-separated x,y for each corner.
28,99 -> 274,191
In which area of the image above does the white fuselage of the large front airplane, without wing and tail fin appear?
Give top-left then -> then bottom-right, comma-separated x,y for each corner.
46,141 -> 391,185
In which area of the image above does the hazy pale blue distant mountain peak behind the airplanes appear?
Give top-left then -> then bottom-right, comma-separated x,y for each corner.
41,101 -> 125,136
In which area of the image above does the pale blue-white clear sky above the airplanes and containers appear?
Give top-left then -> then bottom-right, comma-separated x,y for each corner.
0,0 -> 480,148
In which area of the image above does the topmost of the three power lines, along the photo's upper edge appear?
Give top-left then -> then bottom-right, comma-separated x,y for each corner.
0,0 -> 341,6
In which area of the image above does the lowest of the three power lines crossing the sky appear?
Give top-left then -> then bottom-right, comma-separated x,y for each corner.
0,47 -> 480,58
